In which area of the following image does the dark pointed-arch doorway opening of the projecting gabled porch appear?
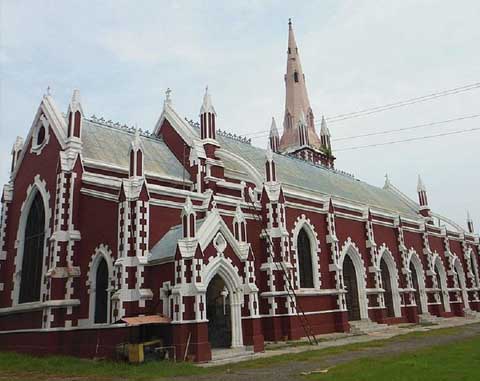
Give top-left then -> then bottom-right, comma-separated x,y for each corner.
207,275 -> 232,348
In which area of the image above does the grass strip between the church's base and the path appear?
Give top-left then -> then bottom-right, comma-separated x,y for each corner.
0,328 -> 472,381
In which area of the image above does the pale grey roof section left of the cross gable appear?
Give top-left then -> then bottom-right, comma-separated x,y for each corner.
82,119 -> 184,180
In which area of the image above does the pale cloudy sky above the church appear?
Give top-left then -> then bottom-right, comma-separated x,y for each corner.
0,0 -> 480,227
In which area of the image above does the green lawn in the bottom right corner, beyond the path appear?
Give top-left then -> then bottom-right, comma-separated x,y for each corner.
306,337 -> 480,381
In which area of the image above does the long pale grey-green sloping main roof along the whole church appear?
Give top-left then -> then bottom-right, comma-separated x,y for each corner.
83,113 -> 418,217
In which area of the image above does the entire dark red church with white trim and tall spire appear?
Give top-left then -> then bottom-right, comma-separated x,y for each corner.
0,23 -> 480,362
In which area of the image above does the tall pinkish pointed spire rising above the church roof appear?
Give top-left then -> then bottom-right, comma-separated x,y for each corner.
280,20 -> 321,152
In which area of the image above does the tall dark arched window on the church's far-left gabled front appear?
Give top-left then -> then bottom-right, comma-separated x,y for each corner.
18,192 -> 45,303
